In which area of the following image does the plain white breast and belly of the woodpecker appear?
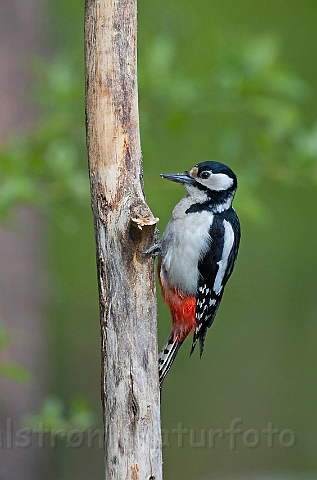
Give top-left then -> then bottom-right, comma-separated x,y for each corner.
161,197 -> 213,295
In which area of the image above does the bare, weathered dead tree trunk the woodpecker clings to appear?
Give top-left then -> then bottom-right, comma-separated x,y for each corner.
85,0 -> 162,480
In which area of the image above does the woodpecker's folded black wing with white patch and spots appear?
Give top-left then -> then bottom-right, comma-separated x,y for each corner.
190,208 -> 240,356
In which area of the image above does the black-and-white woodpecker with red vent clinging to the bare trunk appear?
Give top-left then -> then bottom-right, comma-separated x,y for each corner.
158,161 -> 240,386
